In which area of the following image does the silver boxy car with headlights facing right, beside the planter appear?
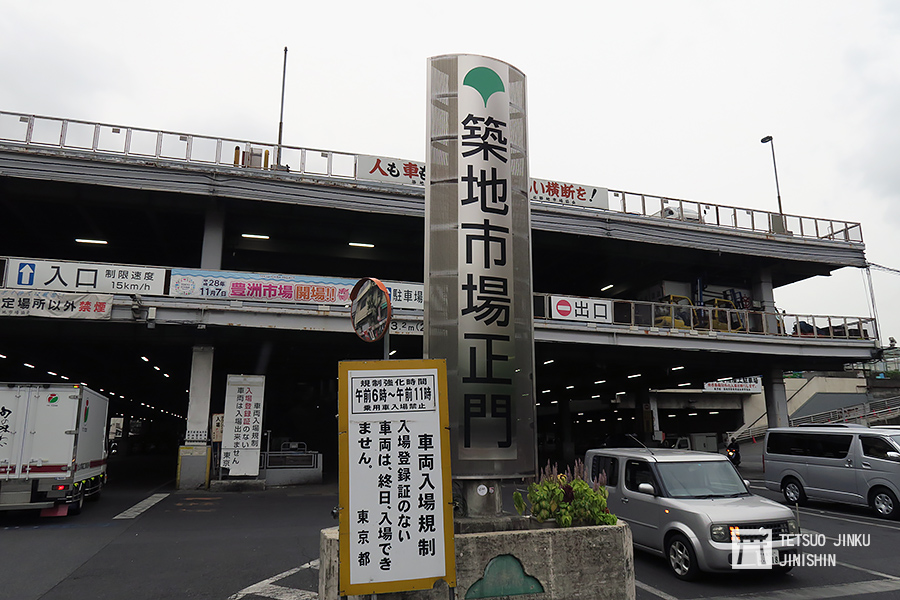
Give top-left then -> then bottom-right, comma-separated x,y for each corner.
585,448 -> 800,580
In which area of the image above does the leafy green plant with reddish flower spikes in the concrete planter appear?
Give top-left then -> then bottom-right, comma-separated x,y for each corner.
513,460 -> 617,527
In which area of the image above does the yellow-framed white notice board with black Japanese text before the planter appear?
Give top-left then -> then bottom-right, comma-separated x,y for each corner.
338,360 -> 456,596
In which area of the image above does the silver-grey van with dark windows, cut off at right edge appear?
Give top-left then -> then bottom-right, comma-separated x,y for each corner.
763,424 -> 900,519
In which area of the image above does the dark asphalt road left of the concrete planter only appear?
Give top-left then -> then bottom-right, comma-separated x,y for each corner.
0,457 -> 337,600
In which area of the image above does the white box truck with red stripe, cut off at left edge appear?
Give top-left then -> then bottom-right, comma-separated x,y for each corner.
0,383 -> 109,516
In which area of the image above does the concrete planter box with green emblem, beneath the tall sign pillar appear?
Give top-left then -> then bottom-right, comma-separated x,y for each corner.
319,522 -> 635,600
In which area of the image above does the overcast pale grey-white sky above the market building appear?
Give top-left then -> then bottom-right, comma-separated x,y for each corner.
0,0 -> 900,343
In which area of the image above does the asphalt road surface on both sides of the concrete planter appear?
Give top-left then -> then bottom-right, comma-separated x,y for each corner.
0,445 -> 900,600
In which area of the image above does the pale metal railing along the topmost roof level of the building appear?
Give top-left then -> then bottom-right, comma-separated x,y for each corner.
0,111 -> 863,243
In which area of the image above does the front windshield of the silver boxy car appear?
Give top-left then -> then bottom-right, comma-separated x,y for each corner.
656,460 -> 750,498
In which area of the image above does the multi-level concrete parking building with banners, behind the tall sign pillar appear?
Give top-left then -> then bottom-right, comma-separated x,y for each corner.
0,112 -> 879,478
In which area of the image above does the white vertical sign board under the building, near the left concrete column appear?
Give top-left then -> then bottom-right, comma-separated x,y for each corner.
220,375 -> 266,476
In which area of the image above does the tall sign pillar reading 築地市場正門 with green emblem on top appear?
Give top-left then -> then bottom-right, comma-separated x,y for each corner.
424,54 -> 537,516
